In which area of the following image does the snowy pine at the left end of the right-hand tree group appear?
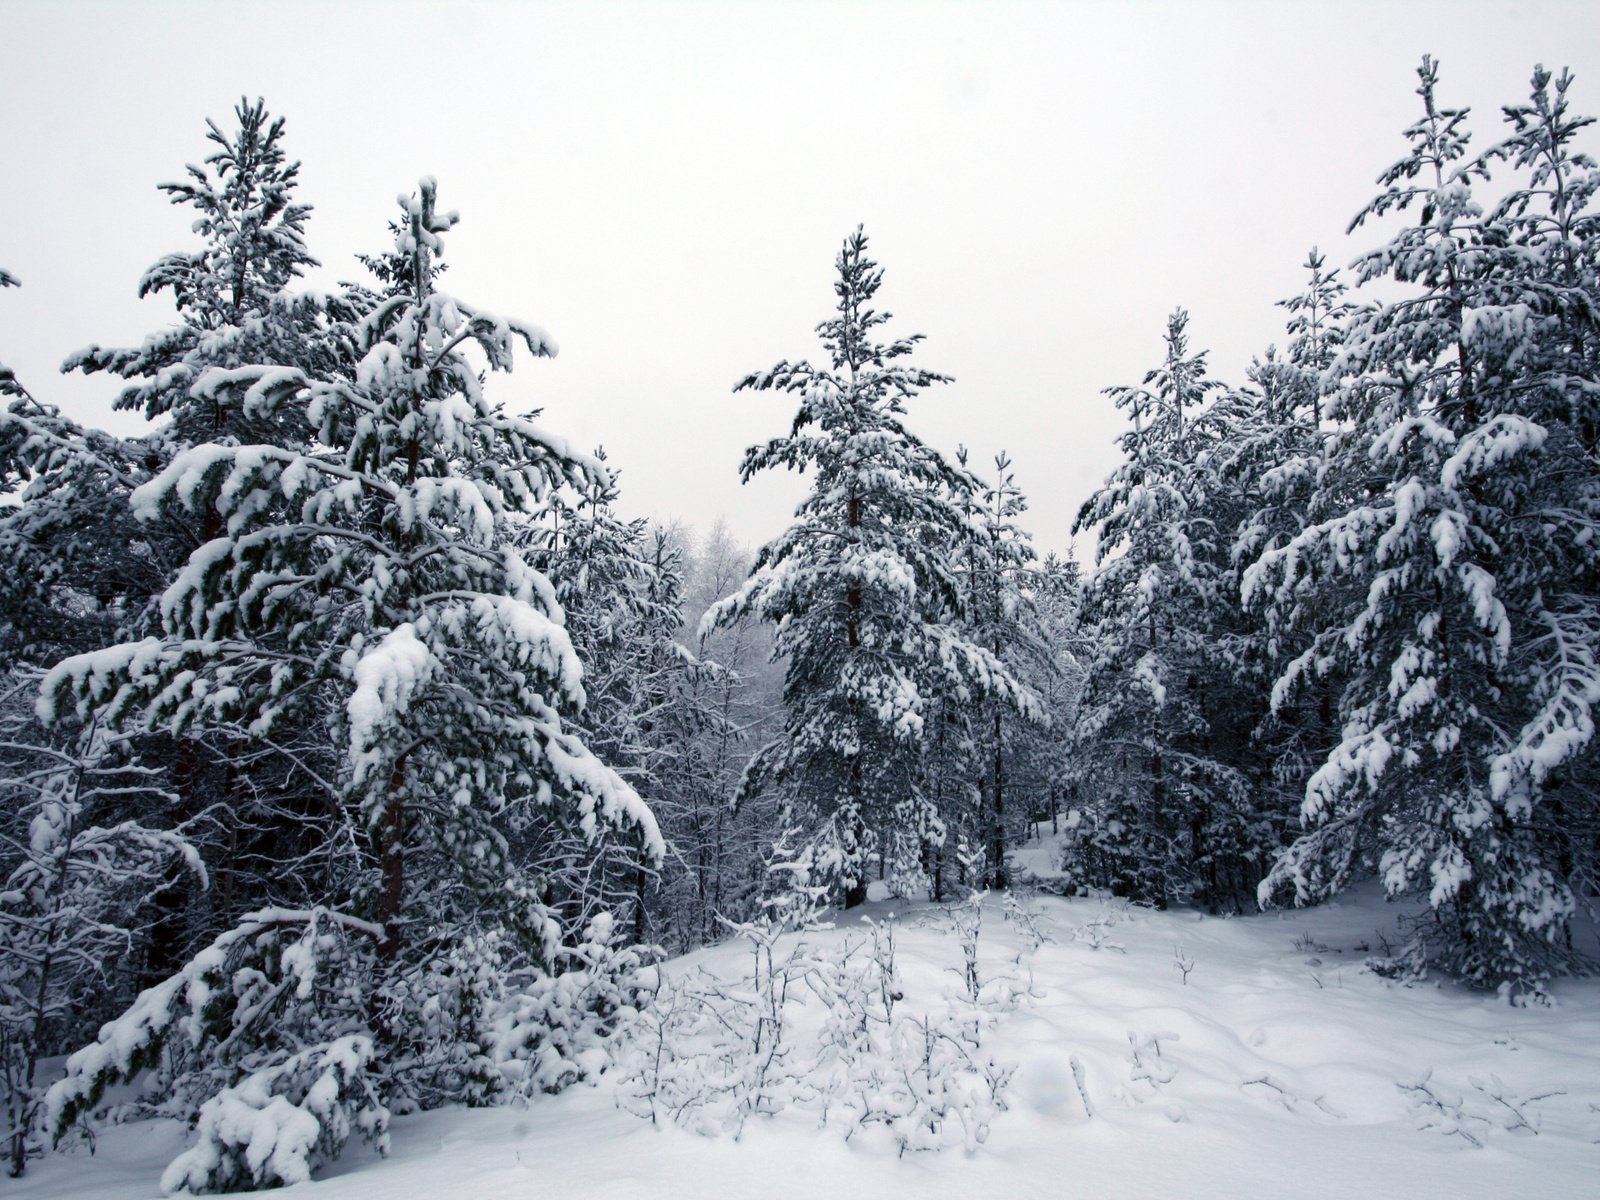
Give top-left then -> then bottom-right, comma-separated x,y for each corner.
1072,309 -> 1248,906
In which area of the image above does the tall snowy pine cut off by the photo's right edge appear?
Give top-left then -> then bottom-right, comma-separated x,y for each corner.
1472,66 -> 1600,944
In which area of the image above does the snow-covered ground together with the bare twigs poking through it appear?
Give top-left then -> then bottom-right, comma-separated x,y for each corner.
11,851 -> 1600,1200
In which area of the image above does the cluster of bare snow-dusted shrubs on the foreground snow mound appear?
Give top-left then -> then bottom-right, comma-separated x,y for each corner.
619,843 -> 1027,1152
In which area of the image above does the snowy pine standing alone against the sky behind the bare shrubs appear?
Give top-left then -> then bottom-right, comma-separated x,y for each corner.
702,229 -> 1037,904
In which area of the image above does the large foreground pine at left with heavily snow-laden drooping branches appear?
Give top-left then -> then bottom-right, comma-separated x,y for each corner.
40,179 -> 661,1190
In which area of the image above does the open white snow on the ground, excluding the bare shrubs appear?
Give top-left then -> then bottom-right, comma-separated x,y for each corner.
6,825 -> 1600,1200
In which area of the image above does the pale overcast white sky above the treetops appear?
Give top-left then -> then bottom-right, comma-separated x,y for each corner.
0,0 -> 1600,563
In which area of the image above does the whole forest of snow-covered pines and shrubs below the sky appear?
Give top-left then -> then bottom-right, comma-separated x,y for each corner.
0,59 -> 1600,1192
